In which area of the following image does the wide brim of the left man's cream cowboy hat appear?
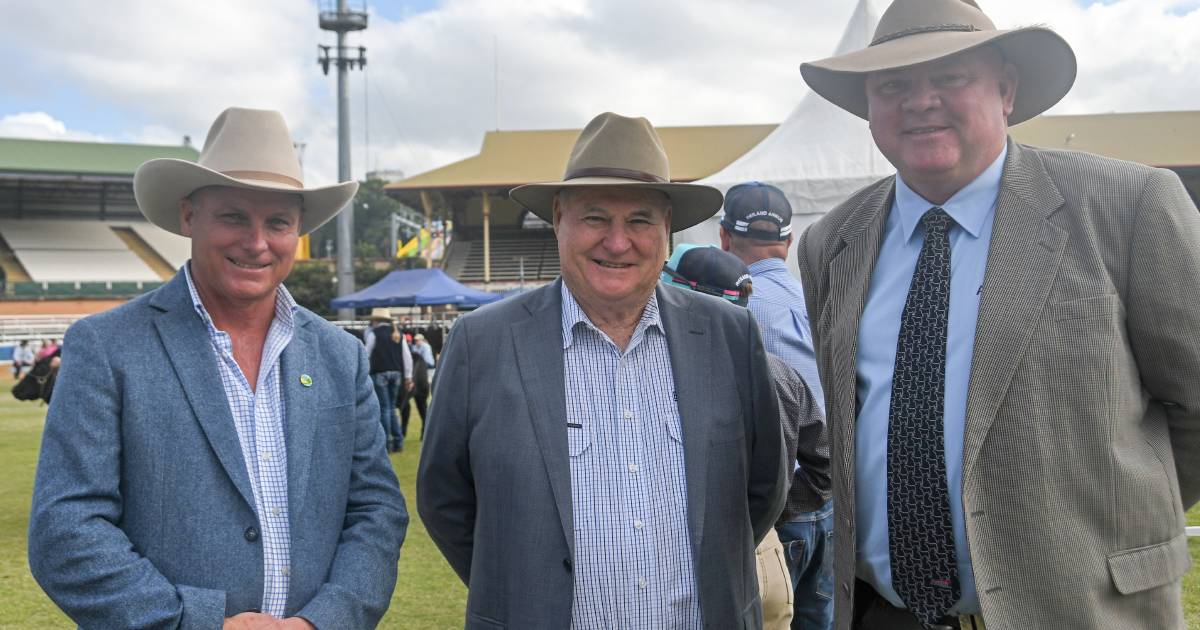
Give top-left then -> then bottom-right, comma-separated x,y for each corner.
133,157 -> 359,235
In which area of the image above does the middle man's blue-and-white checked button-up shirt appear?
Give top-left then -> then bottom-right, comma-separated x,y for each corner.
563,283 -> 702,630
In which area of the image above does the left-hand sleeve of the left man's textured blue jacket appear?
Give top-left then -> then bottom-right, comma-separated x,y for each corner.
29,319 -> 226,630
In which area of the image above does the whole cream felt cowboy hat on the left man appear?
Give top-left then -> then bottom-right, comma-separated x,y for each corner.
133,107 -> 359,234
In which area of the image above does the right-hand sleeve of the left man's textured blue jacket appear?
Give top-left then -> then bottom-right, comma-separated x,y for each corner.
298,347 -> 408,630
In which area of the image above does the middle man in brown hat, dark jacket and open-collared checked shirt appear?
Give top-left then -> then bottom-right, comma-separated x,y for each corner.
416,114 -> 786,630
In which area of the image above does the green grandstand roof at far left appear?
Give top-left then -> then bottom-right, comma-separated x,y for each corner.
0,138 -> 200,176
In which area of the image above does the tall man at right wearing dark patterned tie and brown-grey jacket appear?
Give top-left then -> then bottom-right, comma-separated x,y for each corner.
799,0 -> 1200,630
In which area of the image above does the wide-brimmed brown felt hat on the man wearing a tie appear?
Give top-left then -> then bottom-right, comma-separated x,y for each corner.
800,0 -> 1076,125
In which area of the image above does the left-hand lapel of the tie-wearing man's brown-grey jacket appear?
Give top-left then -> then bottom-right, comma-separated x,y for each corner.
822,182 -> 895,470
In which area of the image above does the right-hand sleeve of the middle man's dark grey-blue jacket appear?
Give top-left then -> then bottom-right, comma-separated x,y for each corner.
742,308 -> 791,545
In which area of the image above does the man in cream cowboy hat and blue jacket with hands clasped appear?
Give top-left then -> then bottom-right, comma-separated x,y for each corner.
29,108 -> 408,629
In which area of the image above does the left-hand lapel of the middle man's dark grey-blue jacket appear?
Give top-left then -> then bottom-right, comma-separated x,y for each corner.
511,280 -> 575,557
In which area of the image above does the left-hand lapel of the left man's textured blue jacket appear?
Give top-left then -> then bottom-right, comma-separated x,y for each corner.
151,272 -> 254,510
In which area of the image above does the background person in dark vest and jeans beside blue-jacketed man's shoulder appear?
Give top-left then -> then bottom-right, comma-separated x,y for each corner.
362,308 -> 413,452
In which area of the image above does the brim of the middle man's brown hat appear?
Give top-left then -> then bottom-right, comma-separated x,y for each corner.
509,178 -> 725,232
